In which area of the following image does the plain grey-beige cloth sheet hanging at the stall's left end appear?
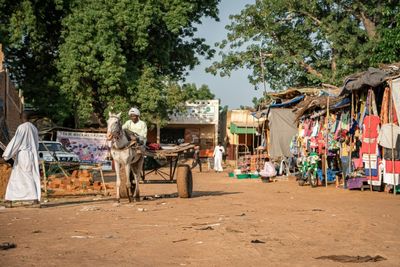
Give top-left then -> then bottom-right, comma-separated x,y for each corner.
268,109 -> 297,158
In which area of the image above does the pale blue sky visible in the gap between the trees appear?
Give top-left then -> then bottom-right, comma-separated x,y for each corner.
186,0 -> 262,109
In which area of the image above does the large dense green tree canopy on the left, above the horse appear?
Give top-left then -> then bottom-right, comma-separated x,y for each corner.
0,0 -> 219,125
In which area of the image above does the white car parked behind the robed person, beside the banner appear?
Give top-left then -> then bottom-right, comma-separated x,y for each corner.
38,141 -> 79,163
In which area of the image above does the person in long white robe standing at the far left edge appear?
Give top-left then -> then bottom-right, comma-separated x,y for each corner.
2,116 -> 41,203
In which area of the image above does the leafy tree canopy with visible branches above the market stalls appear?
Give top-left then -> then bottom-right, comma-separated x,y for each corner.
207,0 -> 400,90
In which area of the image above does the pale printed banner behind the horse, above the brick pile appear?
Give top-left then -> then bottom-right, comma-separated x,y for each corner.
57,131 -> 111,170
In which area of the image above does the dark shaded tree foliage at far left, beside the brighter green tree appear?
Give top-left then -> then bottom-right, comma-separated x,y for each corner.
0,0 -> 71,120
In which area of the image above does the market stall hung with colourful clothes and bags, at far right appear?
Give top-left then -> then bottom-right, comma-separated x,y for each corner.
291,64 -> 400,193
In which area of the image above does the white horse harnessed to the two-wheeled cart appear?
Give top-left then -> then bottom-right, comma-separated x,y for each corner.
107,112 -> 144,202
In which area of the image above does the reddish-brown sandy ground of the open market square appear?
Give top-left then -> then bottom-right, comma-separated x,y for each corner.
0,171 -> 400,266
